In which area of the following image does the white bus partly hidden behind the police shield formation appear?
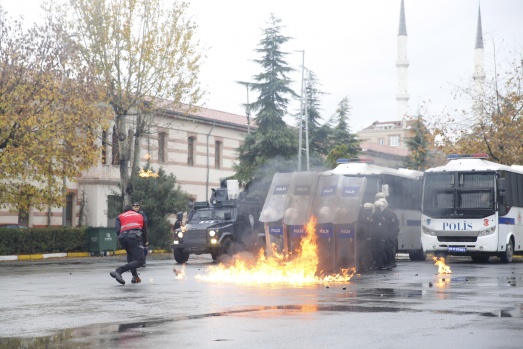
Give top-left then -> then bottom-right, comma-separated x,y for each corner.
331,158 -> 426,261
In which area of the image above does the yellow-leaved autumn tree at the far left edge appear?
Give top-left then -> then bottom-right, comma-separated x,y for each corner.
0,7 -> 108,211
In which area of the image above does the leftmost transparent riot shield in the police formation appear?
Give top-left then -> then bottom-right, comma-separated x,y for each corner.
260,172 -> 292,254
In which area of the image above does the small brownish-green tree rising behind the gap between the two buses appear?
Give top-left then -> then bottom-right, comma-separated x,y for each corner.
405,116 -> 434,171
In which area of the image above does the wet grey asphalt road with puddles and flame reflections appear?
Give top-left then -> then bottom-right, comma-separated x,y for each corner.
0,254 -> 523,349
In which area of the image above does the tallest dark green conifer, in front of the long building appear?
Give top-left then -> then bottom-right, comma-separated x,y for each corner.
234,15 -> 297,184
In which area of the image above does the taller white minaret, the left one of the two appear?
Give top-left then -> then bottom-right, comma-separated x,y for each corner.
396,0 -> 409,128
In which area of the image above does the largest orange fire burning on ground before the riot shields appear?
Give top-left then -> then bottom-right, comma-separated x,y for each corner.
196,217 -> 355,285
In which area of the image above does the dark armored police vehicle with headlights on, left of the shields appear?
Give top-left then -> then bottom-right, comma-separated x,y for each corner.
172,180 -> 265,264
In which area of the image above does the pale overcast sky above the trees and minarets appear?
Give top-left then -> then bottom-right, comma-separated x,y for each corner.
0,0 -> 523,132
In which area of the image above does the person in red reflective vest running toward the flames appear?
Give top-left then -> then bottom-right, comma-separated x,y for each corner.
109,206 -> 149,285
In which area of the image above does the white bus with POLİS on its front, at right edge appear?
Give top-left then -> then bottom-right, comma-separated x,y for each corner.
421,154 -> 523,263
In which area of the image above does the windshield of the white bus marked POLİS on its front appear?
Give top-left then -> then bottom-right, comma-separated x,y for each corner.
422,172 -> 496,218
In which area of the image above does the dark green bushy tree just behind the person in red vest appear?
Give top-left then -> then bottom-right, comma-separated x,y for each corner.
108,166 -> 190,249
